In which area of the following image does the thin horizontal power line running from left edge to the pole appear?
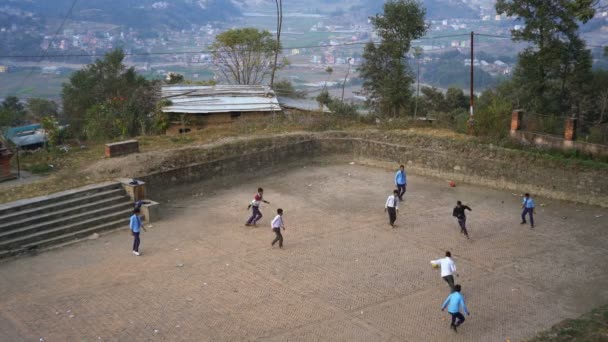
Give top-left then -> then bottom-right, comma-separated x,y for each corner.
0,33 -> 468,58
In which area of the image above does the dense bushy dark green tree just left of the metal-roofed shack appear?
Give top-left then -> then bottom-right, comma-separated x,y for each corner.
62,49 -> 157,138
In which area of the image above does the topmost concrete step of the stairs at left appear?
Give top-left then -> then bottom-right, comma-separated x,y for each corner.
0,182 -> 122,219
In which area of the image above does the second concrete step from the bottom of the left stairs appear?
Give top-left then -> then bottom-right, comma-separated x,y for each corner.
0,209 -> 132,250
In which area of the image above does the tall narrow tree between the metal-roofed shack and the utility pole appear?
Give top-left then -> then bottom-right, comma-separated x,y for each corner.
359,0 -> 427,116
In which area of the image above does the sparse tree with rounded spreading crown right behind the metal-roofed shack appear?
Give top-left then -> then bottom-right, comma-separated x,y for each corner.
211,28 -> 281,84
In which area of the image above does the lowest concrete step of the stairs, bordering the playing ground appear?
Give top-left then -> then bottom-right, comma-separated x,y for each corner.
0,217 -> 129,259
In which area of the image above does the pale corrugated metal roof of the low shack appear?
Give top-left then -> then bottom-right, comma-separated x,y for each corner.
161,85 -> 281,114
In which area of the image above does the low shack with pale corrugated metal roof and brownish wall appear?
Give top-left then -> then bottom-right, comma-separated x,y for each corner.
161,85 -> 281,134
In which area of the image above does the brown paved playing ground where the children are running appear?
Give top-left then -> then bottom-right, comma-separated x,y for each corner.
0,163 -> 608,342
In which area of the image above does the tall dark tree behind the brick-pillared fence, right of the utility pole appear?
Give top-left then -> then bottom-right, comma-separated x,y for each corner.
496,0 -> 597,115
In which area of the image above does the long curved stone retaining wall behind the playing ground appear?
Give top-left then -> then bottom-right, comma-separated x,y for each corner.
141,131 -> 608,207
